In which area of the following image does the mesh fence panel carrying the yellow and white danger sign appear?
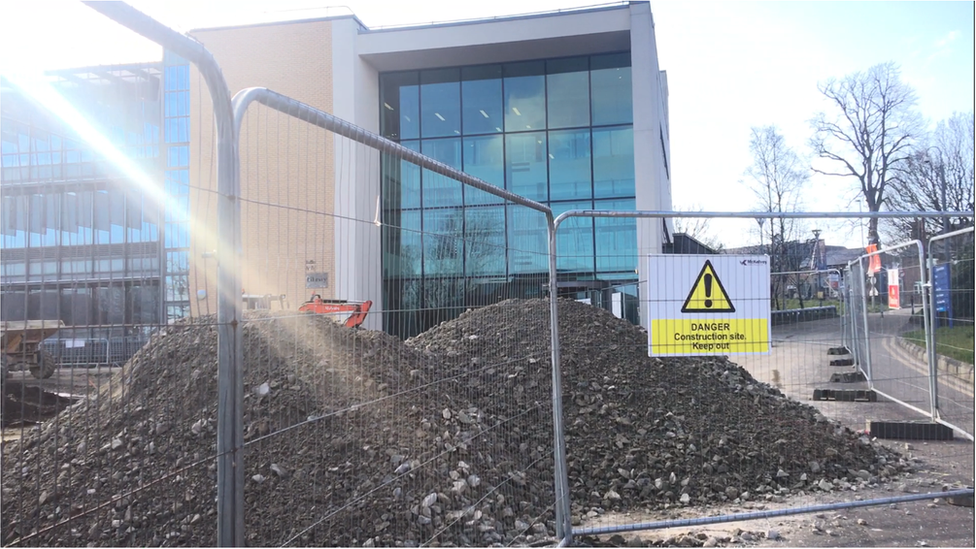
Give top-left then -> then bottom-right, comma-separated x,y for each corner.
556,211 -> 971,536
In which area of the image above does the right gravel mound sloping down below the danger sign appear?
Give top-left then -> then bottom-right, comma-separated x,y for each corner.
407,300 -> 906,517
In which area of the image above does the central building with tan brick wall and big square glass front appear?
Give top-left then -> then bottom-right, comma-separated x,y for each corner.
190,2 -> 671,335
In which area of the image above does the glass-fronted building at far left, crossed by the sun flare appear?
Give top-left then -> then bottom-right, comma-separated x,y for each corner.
0,57 -> 189,363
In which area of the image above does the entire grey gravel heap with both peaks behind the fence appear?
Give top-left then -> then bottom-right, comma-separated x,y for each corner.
0,300 -> 907,546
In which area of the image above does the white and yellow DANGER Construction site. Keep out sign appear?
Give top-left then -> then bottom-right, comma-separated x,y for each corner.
647,254 -> 770,356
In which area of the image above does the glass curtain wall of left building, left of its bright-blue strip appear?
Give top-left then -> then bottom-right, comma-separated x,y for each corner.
0,64 -> 169,363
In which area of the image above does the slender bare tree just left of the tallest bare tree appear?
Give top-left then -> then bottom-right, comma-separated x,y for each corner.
746,126 -> 809,308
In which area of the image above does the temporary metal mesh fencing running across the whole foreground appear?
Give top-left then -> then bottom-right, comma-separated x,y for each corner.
2,3 -> 972,546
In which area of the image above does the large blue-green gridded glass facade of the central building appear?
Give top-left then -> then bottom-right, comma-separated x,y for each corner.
380,52 -> 637,336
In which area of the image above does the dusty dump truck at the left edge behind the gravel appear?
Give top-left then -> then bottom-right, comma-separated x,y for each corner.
0,320 -> 64,380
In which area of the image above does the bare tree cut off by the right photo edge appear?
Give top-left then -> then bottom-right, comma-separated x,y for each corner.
885,112 -> 976,239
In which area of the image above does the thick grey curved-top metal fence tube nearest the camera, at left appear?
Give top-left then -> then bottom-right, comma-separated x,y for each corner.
85,1 -> 245,547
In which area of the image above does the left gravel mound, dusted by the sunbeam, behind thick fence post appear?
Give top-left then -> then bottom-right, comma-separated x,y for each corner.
2,315 -> 438,546
